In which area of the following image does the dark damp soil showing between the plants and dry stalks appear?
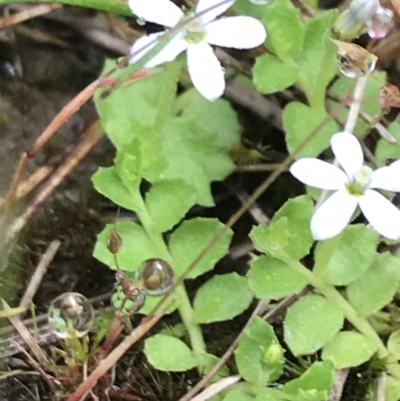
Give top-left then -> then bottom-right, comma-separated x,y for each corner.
0,3 -> 396,401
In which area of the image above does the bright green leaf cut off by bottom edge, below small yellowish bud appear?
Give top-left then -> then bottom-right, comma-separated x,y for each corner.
282,361 -> 335,401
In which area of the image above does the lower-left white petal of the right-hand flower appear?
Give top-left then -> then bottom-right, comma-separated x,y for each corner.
311,190 -> 357,240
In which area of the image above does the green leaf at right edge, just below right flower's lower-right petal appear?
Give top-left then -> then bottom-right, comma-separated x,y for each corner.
347,252 -> 400,316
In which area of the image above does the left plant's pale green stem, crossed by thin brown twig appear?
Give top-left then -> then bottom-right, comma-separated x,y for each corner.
133,193 -> 207,373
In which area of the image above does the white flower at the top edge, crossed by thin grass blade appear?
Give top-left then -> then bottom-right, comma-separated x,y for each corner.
129,0 -> 266,101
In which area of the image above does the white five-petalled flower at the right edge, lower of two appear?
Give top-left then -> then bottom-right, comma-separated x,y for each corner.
290,132 -> 400,240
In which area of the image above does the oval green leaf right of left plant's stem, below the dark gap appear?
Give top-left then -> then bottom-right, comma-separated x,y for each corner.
193,273 -> 253,323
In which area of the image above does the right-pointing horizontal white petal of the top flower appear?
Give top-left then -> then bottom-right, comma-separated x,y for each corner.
205,16 -> 267,49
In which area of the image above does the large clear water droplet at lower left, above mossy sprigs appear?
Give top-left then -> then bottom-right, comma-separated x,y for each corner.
48,292 -> 94,339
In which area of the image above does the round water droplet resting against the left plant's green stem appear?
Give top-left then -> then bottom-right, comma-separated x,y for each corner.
136,259 -> 174,296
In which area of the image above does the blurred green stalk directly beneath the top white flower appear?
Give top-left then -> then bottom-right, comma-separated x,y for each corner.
154,59 -> 183,133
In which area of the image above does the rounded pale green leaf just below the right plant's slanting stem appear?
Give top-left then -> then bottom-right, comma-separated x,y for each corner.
284,294 -> 344,356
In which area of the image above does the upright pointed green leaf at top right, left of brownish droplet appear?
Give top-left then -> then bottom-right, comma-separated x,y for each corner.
295,11 -> 338,106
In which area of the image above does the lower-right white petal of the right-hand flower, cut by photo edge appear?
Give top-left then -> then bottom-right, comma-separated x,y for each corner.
359,189 -> 400,240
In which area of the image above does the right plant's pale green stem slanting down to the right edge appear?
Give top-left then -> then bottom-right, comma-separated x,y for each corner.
280,257 -> 400,380
